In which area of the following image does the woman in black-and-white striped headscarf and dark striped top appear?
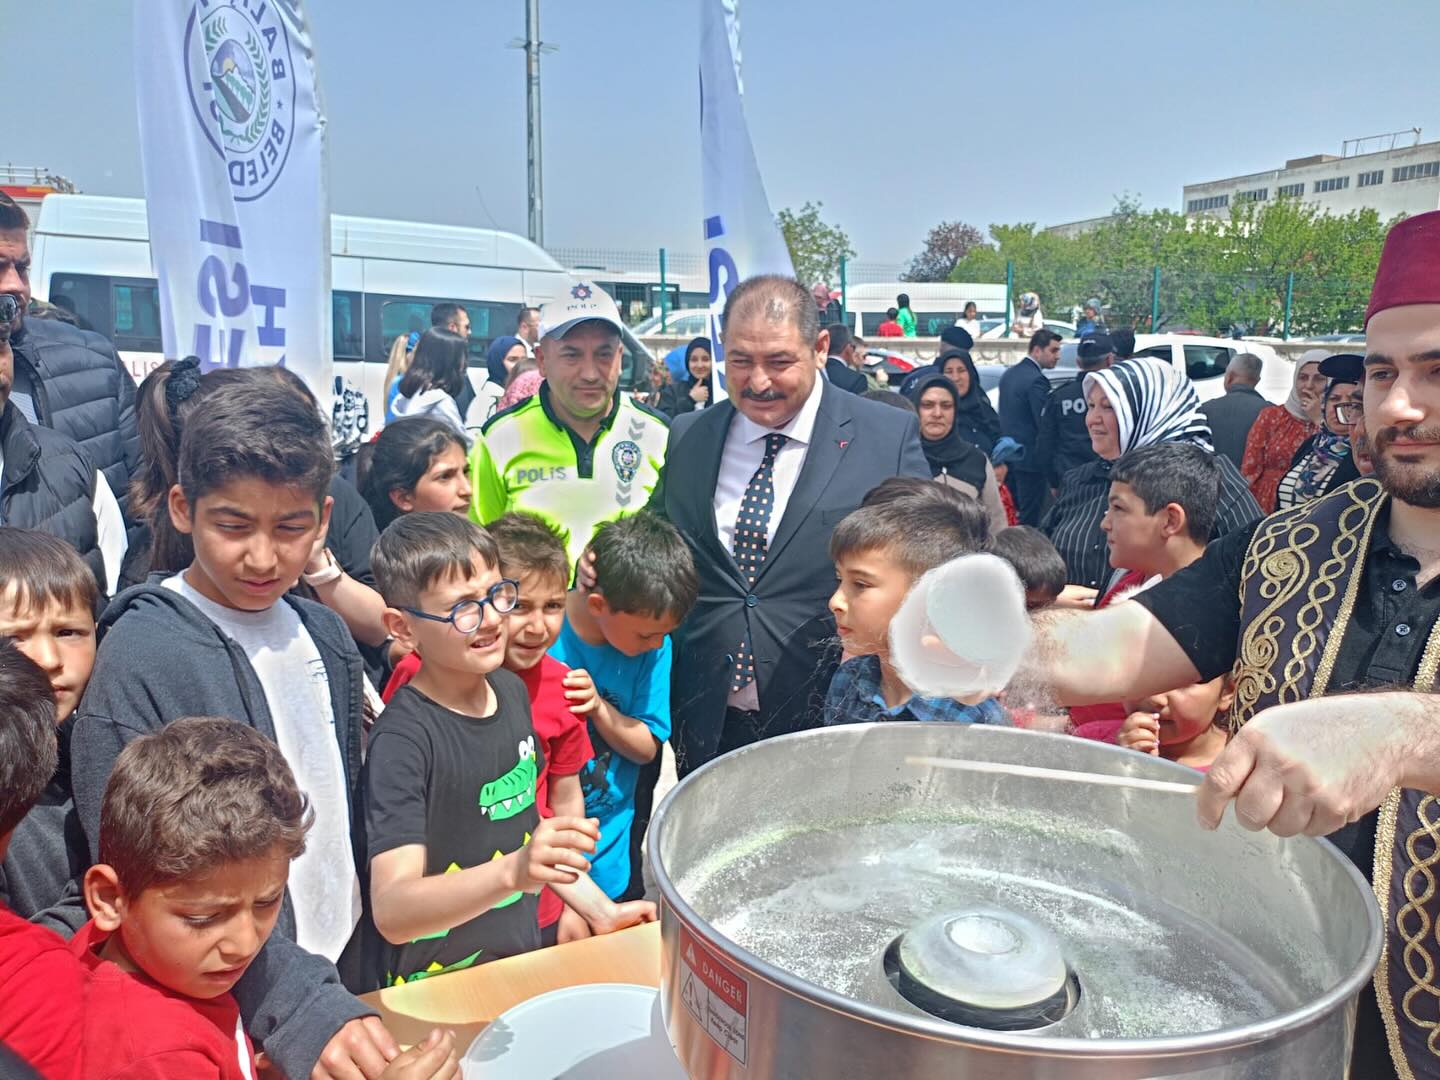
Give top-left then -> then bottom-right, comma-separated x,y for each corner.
1041,357 -> 1261,589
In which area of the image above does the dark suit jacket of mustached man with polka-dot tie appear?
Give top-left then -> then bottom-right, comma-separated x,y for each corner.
649,383 -> 930,773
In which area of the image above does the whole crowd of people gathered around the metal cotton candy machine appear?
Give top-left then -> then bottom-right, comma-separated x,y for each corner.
0,175 -> 1440,1080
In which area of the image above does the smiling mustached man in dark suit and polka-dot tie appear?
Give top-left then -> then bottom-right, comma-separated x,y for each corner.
649,276 -> 930,775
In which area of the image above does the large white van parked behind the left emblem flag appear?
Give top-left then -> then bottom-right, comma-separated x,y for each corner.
30,194 -> 651,429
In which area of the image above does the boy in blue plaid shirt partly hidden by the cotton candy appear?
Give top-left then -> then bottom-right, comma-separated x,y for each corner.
824,495 -> 1005,724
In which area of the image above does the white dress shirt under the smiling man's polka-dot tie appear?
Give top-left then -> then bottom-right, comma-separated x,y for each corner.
713,379 -> 825,710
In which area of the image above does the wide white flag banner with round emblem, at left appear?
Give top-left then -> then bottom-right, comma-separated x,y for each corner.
135,0 -> 331,402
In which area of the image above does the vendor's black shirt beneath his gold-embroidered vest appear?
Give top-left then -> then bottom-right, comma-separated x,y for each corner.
1135,504 -> 1440,1080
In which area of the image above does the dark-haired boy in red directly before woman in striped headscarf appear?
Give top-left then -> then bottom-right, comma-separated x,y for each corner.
1070,442 -> 1220,743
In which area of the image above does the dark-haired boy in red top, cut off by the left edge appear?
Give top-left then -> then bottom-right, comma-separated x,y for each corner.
0,639 -> 85,1077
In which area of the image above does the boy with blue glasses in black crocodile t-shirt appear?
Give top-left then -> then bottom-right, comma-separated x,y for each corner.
364,513 -> 599,985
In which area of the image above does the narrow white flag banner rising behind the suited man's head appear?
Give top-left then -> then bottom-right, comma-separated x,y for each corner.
700,0 -> 795,373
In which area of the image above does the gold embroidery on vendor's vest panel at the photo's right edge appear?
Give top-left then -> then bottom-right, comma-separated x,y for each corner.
1372,621 -> 1440,1080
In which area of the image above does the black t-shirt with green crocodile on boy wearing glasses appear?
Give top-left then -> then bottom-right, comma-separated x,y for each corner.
364,670 -> 541,985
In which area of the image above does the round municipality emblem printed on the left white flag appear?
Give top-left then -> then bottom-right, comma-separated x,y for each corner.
184,0 -> 295,202
